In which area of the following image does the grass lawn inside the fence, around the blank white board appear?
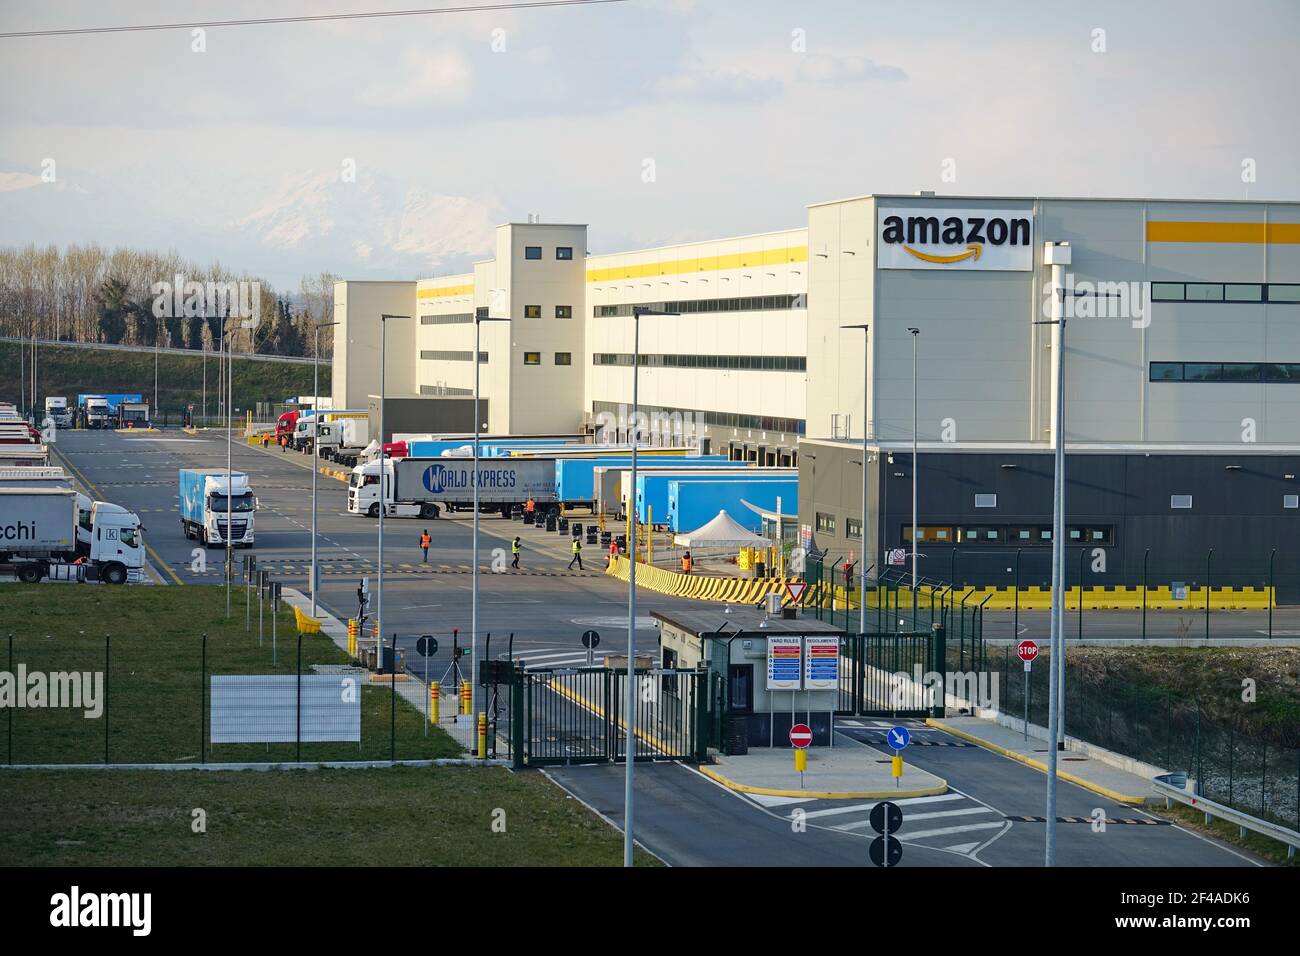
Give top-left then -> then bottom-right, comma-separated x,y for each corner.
0,584 -> 462,763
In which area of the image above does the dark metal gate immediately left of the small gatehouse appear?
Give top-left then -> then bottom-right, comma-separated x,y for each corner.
510,667 -> 711,767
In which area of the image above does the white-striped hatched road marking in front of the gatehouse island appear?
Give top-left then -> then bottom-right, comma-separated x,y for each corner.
746,792 -> 1011,855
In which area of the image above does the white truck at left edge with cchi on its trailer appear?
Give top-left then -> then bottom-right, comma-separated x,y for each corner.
0,486 -> 144,584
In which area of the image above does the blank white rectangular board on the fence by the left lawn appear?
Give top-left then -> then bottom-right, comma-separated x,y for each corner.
211,674 -> 361,744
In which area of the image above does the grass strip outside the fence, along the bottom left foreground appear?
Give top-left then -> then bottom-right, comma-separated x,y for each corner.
0,767 -> 655,866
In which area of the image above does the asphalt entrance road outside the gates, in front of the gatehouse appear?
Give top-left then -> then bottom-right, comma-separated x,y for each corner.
547,718 -> 1257,868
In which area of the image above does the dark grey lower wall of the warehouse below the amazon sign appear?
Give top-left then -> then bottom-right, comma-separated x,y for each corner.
800,444 -> 1300,604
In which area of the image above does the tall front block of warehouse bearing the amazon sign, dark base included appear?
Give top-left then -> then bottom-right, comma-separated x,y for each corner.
800,195 -> 1300,600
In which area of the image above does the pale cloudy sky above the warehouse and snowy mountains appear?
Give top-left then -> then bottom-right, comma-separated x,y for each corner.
0,0 -> 1300,285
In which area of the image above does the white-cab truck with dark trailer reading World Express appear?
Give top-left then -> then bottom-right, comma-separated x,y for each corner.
347,458 -> 556,519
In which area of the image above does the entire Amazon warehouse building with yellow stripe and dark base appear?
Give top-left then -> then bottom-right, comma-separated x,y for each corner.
333,194 -> 1300,593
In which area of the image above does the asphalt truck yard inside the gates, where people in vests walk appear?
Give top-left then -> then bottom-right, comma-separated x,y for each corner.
48,429 -> 712,676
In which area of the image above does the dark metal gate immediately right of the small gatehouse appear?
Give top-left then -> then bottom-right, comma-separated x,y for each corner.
835,626 -> 946,717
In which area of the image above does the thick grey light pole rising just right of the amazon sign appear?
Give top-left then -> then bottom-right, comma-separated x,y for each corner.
1034,242 -> 1066,866
